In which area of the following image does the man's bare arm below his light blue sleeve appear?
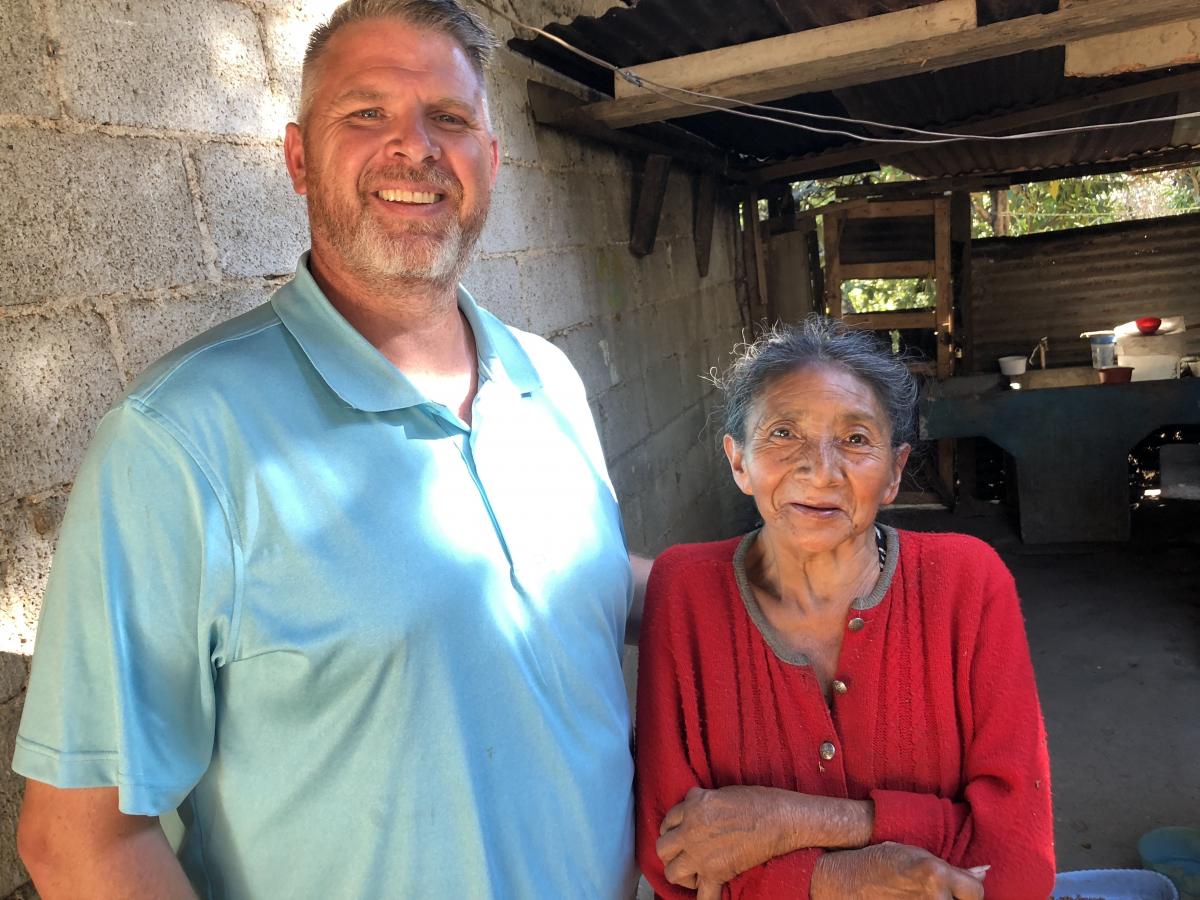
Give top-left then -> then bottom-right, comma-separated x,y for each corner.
17,779 -> 196,900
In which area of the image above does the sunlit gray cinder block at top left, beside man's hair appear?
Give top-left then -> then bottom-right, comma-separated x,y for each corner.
59,0 -> 279,134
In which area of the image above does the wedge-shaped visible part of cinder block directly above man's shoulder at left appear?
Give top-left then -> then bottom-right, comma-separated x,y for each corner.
116,282 -> 275,379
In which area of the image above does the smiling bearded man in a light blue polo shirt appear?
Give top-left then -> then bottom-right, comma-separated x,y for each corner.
13,0 -> 648,900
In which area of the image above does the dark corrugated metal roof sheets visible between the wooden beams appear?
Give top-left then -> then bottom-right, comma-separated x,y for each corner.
511,0 -> 1200,178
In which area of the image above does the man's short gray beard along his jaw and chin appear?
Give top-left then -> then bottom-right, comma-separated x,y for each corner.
313,190 -> 487,286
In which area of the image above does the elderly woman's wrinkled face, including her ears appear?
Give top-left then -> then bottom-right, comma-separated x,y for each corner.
725,365 -> 910,553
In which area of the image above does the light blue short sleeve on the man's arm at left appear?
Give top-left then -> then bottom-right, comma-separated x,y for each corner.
13,401 -> 236,815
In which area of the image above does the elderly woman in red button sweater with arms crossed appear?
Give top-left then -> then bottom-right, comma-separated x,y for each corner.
637,317 -> 1054,900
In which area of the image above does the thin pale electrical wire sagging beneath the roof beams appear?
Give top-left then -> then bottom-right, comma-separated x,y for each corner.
475,0 -> 1200,145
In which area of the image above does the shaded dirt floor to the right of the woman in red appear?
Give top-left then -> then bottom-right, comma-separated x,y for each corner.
881,502 -> 1200,871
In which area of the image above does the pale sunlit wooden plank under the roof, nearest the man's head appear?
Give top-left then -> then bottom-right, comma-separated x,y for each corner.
613,0 -> 976,98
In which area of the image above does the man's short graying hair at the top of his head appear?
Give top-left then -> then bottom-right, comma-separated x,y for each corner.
299,0 -> 499,125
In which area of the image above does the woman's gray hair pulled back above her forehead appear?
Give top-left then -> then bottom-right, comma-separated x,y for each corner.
713,314 -> 919,446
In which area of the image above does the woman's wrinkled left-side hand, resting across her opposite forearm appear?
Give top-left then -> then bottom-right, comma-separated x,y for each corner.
656,786 -> 787,900
